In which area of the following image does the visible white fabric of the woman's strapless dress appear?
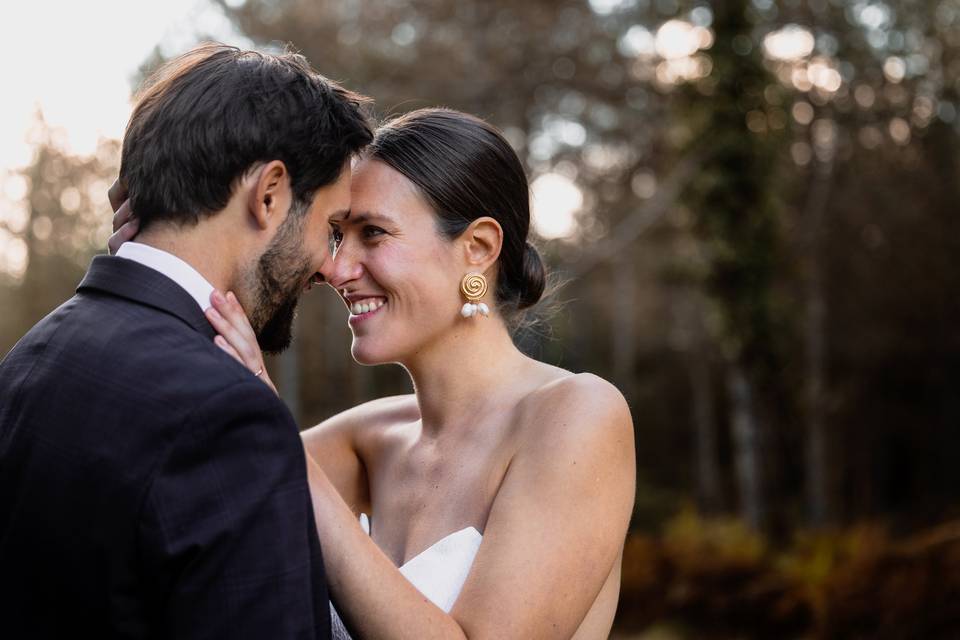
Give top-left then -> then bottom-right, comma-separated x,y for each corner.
330,513 -> 483,640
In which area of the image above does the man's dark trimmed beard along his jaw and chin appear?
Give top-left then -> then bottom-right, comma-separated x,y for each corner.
248,205 -> 311,354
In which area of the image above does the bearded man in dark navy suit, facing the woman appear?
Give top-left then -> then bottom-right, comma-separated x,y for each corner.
0,45 -> 371,639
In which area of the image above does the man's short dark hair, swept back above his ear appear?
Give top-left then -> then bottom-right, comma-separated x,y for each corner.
120,44 -> 373,229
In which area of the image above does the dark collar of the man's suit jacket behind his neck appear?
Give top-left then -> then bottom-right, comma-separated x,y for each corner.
77,256 -> 216,339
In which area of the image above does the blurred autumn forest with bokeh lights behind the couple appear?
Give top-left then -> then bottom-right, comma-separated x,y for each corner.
0,0 -> 960,638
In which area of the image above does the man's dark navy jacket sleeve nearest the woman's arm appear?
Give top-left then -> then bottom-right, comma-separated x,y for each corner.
140,380 -> 329,640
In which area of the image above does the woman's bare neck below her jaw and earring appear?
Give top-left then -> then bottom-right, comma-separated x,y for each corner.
403,317 -> 529,435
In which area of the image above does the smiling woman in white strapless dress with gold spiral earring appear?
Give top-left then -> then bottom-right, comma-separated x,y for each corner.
141,109 -> 635,639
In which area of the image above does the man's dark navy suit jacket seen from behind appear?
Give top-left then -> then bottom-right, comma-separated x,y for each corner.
0,256 -> 330,640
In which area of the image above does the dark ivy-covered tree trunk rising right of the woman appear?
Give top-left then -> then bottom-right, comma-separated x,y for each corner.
686,2 -> 790,528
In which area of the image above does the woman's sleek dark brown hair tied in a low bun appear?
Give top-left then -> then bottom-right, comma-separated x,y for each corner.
366,108 -> 546,310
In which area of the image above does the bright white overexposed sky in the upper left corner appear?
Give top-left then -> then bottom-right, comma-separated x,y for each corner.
0,0 -> 249,171
